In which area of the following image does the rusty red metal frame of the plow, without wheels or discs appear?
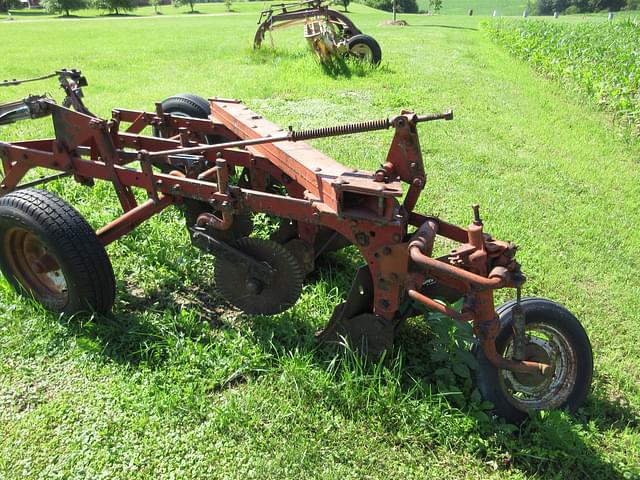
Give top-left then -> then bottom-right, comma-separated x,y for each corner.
0,98 -> 547,372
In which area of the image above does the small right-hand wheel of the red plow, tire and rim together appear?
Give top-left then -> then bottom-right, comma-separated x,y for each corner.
474,298 -> 593,422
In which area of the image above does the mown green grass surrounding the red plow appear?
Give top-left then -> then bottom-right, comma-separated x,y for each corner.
0,5 -> 640,479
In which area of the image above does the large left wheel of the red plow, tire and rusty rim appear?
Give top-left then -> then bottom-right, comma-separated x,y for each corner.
0,189 -> 115,315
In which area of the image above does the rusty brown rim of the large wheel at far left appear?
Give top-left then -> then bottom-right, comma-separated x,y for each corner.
3,227 -> 69,309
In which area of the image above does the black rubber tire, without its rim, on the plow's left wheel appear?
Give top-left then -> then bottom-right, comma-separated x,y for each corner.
0,188 -> 116,315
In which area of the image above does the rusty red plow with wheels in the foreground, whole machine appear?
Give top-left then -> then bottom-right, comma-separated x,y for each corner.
0,70 -> 593,420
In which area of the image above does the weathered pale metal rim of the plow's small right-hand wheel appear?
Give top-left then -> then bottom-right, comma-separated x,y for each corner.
499,323 -> 577,411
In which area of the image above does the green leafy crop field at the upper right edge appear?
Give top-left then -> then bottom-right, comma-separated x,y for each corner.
484,18 -> 640,132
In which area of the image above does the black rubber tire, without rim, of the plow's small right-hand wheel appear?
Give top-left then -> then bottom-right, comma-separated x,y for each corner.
473,297 -> 593,423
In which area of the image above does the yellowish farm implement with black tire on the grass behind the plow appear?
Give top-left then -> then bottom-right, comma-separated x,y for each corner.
253,0 -> 382,65
